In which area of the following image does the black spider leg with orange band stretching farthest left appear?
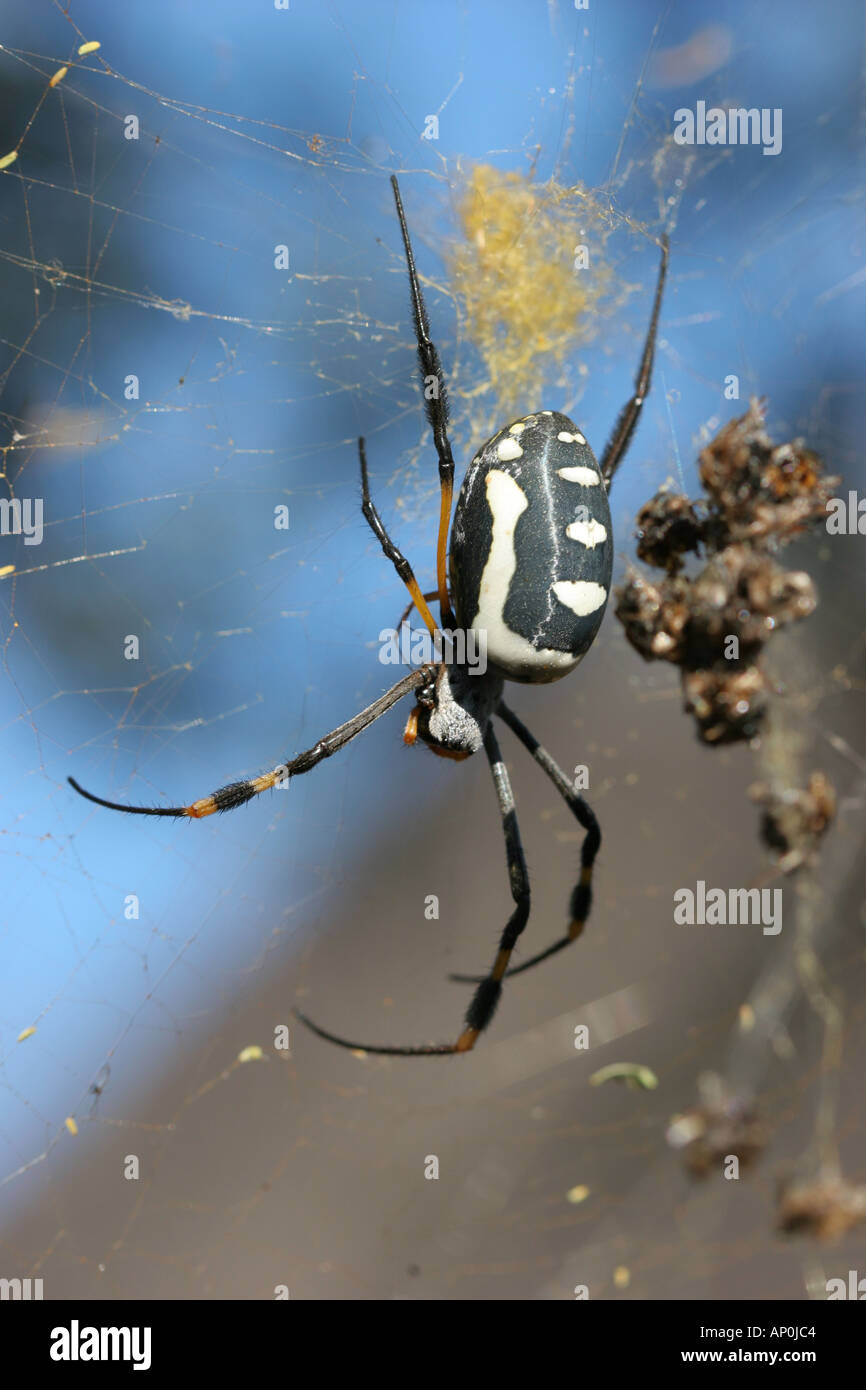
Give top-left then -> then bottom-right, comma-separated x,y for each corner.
67,666 -> 436,820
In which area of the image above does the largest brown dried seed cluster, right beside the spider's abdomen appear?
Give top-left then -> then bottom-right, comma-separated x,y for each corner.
616,400 -> 838,744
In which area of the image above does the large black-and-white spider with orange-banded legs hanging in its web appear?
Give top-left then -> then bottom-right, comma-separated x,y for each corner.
70,177 -> 669,1056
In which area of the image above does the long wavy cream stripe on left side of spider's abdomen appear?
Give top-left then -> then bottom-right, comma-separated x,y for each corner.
470,468 -> 583,680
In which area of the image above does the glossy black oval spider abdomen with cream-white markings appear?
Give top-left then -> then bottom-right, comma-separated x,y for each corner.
450,410 -> 613,682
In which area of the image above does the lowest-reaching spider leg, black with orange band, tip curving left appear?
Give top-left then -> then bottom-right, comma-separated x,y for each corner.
295,724 -> 530,1056
